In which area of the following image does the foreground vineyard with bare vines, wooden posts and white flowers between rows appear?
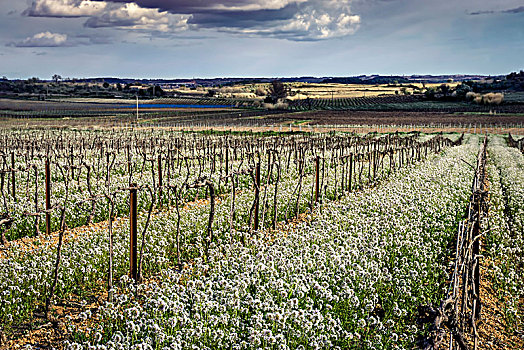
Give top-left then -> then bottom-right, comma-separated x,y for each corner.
0,129 -> 524,349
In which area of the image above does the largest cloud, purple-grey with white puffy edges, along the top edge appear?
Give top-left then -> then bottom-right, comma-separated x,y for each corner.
24,0 -> 360,41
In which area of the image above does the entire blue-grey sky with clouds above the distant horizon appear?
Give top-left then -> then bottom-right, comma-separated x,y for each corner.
0,0 -> 524,79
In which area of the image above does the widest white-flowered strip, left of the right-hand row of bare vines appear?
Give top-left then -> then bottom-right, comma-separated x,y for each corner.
55,137 -> 478,349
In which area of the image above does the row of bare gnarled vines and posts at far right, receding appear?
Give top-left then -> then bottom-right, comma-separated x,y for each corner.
419,135 -> 488,350
